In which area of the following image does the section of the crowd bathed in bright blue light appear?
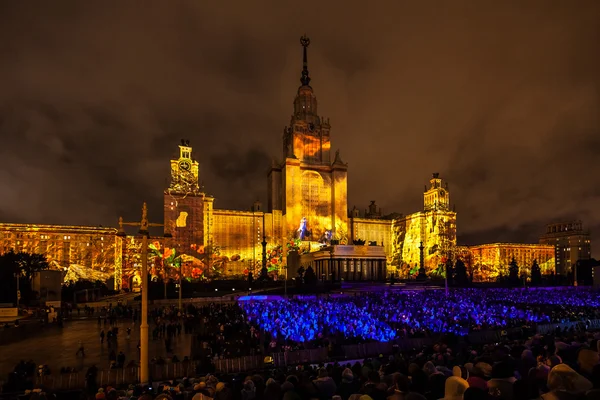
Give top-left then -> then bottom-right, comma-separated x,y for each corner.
240,289 -> 600,342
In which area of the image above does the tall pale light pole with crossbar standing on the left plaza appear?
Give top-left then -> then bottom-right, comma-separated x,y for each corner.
117,202 -> 171,384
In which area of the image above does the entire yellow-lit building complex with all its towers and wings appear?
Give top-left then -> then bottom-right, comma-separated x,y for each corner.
0,37 -> 576,289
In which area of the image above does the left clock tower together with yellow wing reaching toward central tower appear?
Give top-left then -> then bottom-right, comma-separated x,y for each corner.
164,141 -> 282,276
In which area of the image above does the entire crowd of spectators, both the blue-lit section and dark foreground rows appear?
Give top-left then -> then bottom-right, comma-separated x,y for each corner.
5,288 -> 600,400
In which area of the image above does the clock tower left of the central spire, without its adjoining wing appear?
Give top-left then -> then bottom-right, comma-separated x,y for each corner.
164,140 -> 214,268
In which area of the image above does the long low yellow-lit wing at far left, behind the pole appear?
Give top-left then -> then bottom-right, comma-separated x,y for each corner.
0,223 -> 123,288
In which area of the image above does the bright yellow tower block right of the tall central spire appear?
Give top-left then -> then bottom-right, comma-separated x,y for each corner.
392,173 -> 456,278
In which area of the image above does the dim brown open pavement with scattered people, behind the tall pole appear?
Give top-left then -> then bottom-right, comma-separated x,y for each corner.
0,319 -> 192,380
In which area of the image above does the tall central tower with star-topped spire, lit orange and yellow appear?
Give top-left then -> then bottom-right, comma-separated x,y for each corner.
269,36 -> 348,242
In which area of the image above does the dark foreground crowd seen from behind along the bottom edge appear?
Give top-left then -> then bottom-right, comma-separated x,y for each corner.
12,332 -> 600,400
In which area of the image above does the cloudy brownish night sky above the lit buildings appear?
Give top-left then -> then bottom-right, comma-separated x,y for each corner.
0,0 -> 600,256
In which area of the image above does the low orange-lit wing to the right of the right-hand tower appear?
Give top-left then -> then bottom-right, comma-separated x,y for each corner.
463,243 -> 555,282
